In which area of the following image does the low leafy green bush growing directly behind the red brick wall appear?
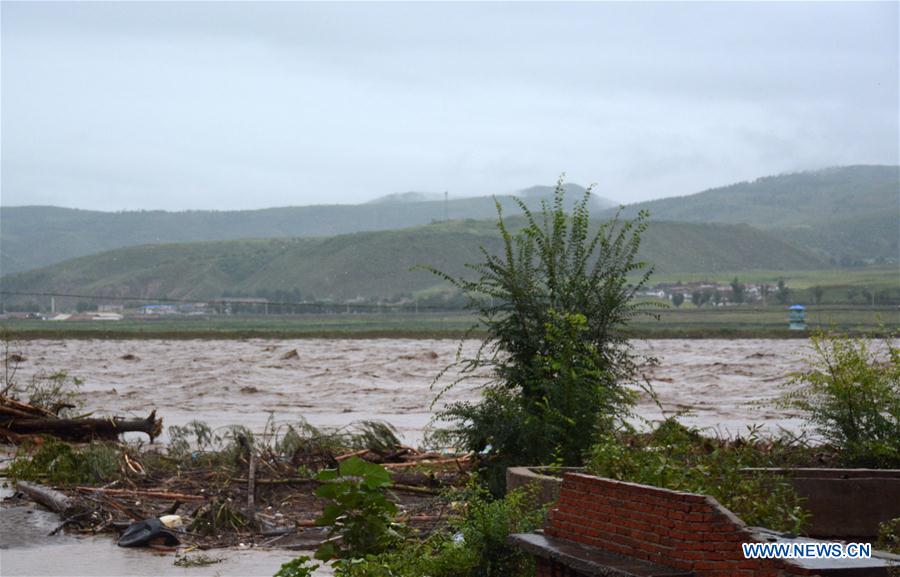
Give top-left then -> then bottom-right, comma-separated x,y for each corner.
588,419 -> 808,533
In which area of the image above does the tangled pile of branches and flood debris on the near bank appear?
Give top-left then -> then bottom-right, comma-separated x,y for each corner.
5,419 -> 472,549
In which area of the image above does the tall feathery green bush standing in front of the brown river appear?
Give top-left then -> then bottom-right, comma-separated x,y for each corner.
432,181 -> 652,495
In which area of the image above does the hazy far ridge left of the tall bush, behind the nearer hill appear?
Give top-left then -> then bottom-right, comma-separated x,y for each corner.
0,184 -> 612,274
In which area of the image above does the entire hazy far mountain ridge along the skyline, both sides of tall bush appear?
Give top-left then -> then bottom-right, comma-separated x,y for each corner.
0,166 -> 900,276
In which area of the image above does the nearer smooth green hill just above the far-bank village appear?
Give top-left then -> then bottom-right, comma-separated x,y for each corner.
0,217 -> 823,301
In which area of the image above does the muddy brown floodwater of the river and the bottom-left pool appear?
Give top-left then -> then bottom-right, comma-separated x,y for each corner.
0,339 -> 836,576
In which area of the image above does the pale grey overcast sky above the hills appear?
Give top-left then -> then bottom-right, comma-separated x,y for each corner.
0,2 -> 900,210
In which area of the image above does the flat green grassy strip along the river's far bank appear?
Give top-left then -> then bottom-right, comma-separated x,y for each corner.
0,306 -> 900,339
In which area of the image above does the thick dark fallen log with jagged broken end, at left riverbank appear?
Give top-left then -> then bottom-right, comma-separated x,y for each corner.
0,410 -> 162,441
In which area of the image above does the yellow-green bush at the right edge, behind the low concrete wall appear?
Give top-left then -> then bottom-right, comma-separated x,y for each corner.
780,332 -> 900,468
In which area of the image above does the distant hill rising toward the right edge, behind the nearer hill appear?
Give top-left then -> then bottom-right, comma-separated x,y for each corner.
608,166 -> 900,263
